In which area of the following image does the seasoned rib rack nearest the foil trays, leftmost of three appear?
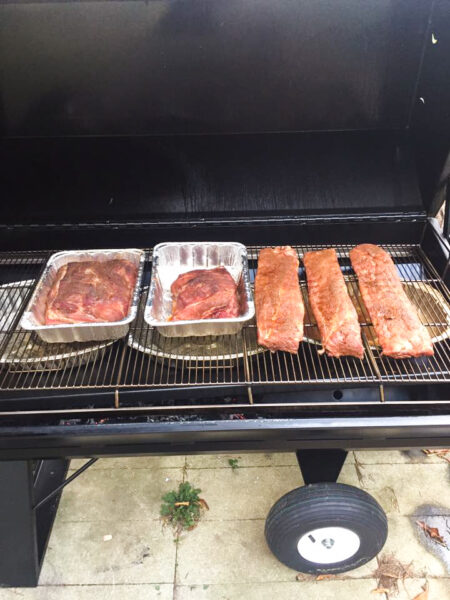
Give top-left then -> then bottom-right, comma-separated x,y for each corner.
255,246 -> 305,354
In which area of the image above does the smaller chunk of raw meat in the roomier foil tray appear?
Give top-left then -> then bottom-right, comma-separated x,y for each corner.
170,267 -> 240,321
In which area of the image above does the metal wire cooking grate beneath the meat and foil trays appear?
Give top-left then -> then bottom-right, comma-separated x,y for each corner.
0,245 -> 450,393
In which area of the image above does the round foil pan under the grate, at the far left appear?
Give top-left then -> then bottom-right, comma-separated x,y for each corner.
0,279 -> 114,372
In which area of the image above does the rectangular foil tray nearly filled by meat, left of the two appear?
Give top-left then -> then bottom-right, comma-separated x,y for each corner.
20,248 -> 145,344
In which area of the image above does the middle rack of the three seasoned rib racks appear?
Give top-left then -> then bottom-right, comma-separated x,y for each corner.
303,248 -> 364,358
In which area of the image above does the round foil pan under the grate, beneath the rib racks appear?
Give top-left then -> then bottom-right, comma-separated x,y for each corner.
302,280 -> 450,350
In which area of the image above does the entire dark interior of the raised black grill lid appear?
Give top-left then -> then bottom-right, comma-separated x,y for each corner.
0,0 -> 450,222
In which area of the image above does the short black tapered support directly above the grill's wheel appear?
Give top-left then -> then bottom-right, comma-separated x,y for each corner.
296,450 -> 347,485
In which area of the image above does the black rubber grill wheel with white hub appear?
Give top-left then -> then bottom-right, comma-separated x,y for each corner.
265,483 -> 388,575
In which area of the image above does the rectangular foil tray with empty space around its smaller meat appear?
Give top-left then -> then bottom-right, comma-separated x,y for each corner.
144,242 -> 255,337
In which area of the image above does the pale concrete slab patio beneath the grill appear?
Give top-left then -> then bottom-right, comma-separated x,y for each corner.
0,450 -> 450,600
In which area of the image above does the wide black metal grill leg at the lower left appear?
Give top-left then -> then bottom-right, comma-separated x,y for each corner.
0,459 -> 69,587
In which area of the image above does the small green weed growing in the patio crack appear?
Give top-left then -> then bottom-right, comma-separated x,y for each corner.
160,481 -> 209,538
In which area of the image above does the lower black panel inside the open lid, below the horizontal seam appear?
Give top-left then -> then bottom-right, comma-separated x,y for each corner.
3,133 -> 421,223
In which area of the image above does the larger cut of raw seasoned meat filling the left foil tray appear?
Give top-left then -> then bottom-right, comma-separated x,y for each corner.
45,260 -> 137,325
